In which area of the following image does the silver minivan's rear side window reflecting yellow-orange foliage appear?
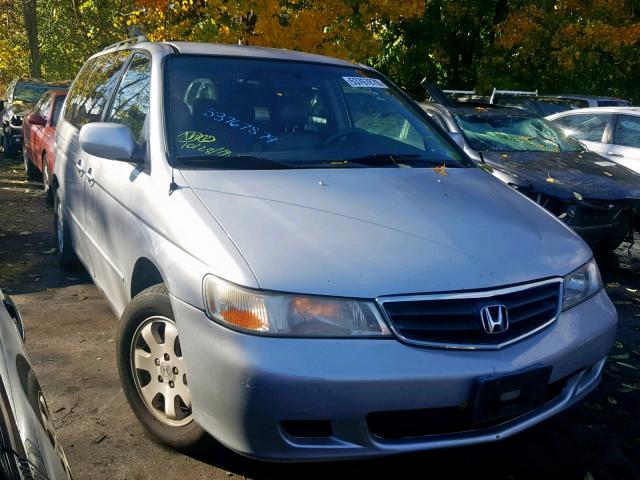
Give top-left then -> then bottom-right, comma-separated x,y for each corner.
64,50 -> 131,128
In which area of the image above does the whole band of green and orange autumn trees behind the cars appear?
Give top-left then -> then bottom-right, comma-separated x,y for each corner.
0,0 -> 640,102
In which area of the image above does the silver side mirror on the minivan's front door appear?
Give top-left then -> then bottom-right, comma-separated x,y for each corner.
80,122 -> 140,163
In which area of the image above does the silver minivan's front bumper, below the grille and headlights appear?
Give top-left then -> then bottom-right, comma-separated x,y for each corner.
172,291 -> 617,461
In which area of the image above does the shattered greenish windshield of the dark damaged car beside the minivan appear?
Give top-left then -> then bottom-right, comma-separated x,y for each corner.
455,112 -> 583,152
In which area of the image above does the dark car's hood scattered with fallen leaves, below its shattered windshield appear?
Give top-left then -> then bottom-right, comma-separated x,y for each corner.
482,151 -> 640,200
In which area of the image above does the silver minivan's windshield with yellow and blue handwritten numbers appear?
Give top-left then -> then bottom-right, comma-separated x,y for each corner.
166,55 -> 464,169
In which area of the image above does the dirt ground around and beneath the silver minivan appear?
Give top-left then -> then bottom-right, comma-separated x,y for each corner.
0,157 -> 640,480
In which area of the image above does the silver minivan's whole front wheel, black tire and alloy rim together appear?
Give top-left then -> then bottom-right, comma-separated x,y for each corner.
116,284 -> 211,452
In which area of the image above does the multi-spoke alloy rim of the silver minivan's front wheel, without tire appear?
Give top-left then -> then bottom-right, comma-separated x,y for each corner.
130,316 -> 192,427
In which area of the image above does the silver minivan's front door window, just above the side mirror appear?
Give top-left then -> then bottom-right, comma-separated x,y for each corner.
107,54 -> 151,143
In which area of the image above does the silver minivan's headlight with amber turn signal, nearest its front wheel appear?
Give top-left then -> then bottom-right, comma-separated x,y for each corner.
204,275 -> 390,338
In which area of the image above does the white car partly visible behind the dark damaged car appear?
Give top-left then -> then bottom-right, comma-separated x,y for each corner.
547,107 -> 640,173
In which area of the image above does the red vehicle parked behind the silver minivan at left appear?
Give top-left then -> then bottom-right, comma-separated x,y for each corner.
22,89 -> 67,204
